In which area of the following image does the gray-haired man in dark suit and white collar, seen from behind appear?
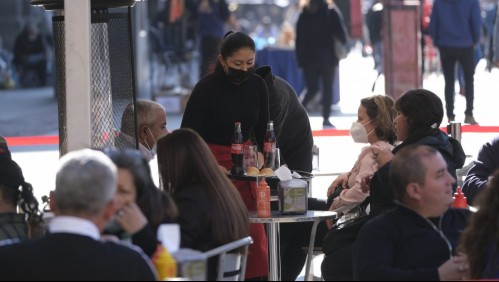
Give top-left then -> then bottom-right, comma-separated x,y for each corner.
0,149 -> 156,281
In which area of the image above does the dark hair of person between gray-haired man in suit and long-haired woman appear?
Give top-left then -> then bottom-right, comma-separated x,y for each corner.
104,149 -> 177,226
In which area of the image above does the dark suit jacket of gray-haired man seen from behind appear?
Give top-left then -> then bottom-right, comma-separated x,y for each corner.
0,233 -> 156,281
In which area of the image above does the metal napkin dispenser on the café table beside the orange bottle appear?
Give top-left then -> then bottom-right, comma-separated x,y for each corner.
277,178 -> 308,214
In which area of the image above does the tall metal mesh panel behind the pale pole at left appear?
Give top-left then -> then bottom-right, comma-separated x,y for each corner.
53,10 -> 137,156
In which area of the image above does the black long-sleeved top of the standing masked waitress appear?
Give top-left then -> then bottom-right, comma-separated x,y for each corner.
180,68 -> 269,148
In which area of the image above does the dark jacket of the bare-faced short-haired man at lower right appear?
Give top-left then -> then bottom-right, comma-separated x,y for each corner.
354,206 -> 471,281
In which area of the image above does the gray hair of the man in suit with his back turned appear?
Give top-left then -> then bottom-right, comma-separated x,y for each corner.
54,149 -> 117,216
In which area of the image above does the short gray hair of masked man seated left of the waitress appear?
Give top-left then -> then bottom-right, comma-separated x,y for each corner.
121,99 -> 165,136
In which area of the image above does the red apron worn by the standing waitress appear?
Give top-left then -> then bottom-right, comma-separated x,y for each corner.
208,144 -> 268,279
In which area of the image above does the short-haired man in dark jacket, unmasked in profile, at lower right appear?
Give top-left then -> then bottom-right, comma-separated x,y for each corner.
353,145 -> 470,281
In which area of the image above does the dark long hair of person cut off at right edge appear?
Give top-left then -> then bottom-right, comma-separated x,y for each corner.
458,170 -> 499,279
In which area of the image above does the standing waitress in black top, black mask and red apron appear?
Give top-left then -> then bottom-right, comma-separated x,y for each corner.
181,32 -> 269,279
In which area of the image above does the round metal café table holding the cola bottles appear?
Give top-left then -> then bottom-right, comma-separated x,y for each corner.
250,211 -> 338,281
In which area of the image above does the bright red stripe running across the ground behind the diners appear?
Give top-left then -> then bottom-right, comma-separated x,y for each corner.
5,125 -> 499,146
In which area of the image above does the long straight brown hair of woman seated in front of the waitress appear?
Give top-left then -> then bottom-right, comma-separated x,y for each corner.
157,128 -> 249,251
